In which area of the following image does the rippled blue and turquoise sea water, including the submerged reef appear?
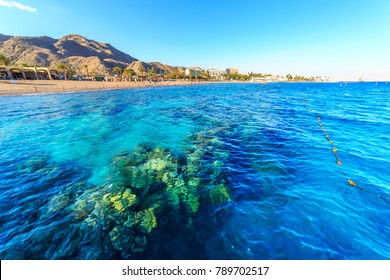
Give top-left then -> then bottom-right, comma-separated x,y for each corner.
0,83 -> 390,259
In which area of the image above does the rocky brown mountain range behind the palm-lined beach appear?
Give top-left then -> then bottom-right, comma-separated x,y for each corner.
0,34 -> 183,73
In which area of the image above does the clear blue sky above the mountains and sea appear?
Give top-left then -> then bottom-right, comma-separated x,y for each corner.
0,0 -> 390,80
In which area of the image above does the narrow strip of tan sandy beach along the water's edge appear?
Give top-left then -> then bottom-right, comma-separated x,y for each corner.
0,80 -> 204,96
